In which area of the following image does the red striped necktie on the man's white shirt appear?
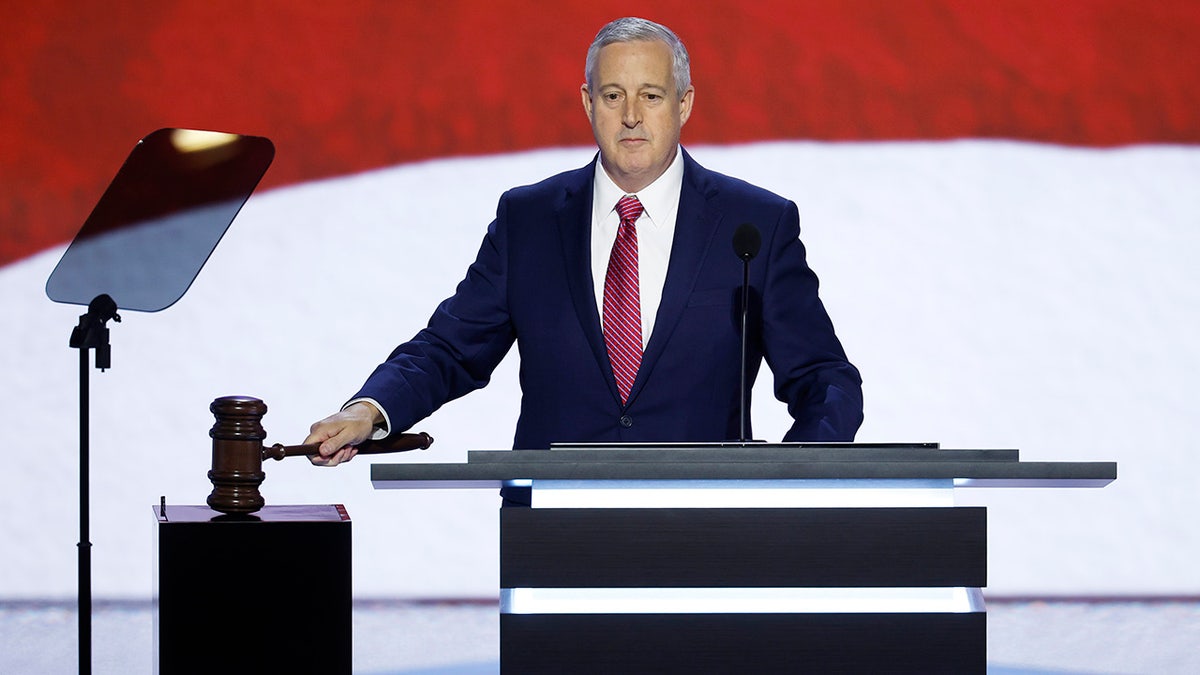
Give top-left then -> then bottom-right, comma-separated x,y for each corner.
604,197 -> 644,404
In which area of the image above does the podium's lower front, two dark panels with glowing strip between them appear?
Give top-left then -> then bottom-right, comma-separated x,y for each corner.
500,497 -> 988,674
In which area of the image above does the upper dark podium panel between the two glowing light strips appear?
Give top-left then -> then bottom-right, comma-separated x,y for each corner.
500,507 -> 988,589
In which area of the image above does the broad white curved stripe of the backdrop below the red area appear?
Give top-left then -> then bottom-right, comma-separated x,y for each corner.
0,141 -> 1200,597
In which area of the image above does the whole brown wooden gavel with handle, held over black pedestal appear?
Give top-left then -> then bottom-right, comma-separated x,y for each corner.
208,396 -> 433,514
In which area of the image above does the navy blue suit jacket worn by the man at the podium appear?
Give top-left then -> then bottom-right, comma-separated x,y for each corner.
355,153 -> 863,449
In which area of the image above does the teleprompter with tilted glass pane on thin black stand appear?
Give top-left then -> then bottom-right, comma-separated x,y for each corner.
46,129 -> 275,674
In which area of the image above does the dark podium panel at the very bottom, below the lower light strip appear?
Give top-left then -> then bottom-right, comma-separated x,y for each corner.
500,613 -> 986,675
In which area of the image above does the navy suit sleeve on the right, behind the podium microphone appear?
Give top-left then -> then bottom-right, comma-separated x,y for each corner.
761,202 -> 863,442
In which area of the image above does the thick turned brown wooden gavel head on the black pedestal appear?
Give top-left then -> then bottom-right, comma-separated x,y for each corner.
208,396 -> 266,514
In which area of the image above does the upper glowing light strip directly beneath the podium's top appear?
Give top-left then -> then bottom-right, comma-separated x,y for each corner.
525,479 -> 954,508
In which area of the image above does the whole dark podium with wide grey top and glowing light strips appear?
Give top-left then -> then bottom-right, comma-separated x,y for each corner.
371,443 -> 1116,674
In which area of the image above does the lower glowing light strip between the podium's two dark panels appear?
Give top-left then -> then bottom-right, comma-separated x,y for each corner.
500,587 -> 985,614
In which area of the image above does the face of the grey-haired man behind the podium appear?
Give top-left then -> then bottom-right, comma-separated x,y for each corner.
582,41 -> 694,192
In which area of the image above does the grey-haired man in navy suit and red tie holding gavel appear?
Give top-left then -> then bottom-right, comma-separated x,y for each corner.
305,18 -> 863,465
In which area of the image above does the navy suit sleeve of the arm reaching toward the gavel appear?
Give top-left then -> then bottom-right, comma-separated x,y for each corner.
354,197 -> 516,431
